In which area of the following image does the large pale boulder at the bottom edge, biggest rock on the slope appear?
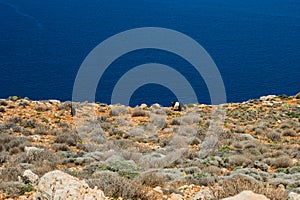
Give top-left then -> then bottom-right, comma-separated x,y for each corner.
33,170 -> 105,200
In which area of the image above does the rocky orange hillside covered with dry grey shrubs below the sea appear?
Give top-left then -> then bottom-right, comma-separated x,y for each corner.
0,94 -> 300,200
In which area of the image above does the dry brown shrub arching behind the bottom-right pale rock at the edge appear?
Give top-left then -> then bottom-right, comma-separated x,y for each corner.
214,175 -> 288,200
